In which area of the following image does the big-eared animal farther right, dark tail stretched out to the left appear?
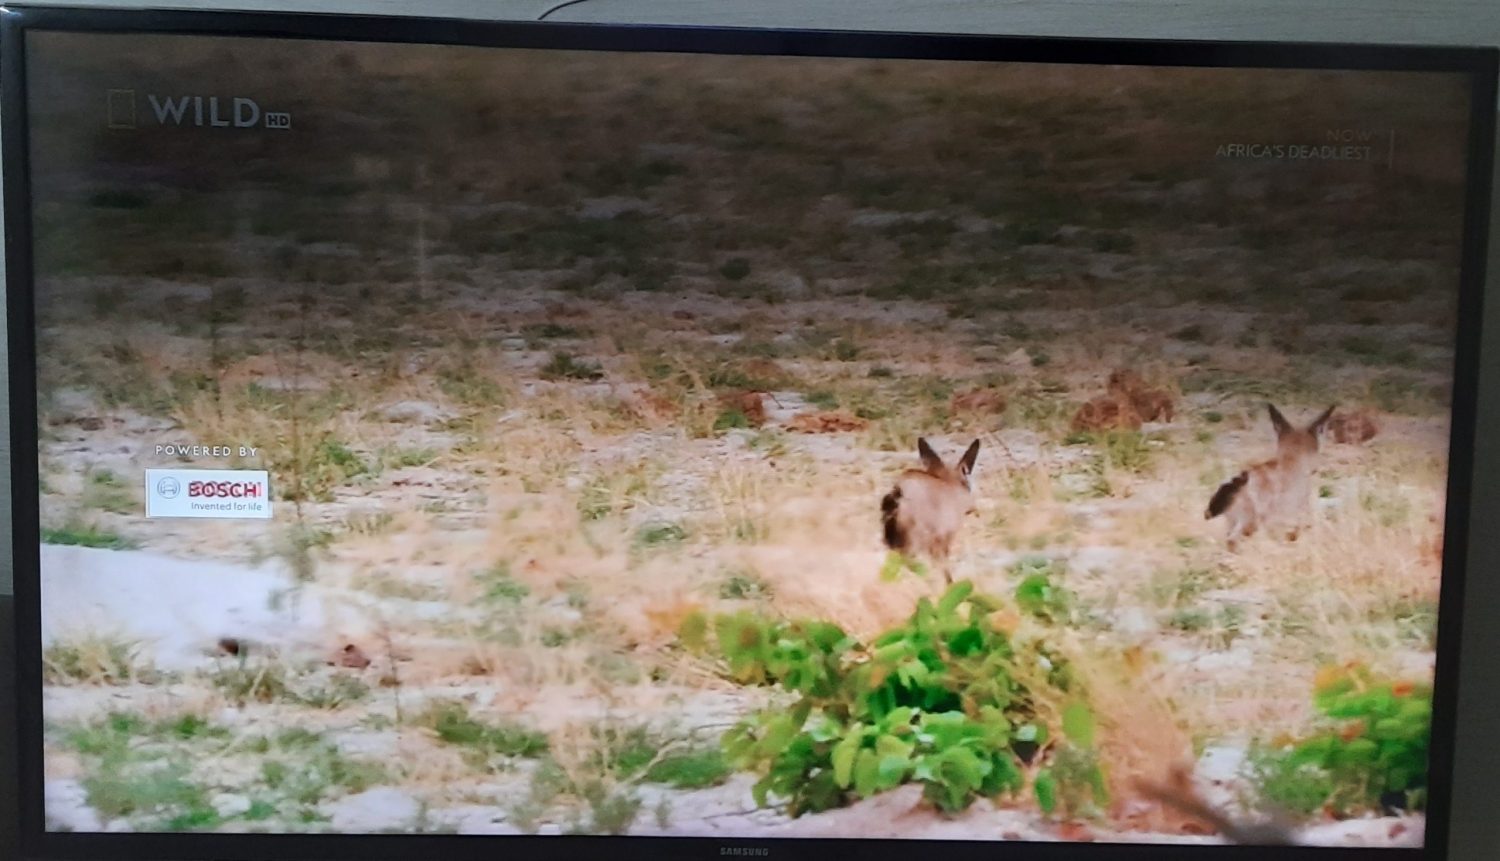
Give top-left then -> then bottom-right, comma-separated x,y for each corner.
1203,404 -> 1334,551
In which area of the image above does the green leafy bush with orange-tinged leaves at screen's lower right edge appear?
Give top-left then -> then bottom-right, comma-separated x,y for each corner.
1253,665 -> 1433,816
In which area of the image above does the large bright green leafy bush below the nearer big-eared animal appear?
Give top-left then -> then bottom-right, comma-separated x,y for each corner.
684,581 -> 1104,816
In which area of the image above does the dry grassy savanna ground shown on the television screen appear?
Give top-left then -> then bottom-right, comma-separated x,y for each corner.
36,33 -> 1463,842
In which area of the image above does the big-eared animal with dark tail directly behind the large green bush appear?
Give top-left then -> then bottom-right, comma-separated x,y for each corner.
881,440 -> 980,584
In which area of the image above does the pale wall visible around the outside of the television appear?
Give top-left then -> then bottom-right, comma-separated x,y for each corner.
0,0 -> 1500,861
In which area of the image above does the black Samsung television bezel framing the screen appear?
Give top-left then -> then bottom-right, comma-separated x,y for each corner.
0,6 -> 1500,861
